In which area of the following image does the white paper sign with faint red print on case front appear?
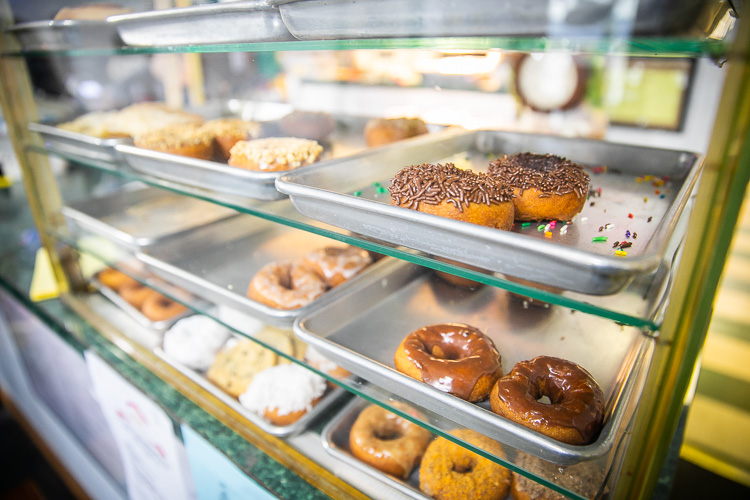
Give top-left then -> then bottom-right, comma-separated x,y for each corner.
84,351 -> 194,500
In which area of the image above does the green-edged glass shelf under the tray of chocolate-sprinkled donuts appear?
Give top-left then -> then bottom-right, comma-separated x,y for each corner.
28,146 -> 687,331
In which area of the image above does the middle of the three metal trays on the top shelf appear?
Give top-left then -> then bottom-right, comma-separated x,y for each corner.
108,0 -> 294,47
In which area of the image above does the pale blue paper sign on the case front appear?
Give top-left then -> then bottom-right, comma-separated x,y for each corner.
182,425 -> 276,500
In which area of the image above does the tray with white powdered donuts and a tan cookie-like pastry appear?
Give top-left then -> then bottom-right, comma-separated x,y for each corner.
154,314 -> 350,437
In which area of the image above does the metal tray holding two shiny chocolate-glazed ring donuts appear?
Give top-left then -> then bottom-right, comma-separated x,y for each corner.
294,262 -> 650,464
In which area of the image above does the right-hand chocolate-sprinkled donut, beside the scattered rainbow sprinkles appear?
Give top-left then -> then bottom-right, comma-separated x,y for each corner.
489,153 -> 591,221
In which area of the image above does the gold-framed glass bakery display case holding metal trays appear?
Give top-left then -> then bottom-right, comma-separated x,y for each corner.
0,0 -> 750,498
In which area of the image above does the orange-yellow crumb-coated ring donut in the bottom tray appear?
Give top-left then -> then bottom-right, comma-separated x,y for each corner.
419,429 -> 511,500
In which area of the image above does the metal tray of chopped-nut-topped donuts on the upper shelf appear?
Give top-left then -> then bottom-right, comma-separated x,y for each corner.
116,111 -> 442,200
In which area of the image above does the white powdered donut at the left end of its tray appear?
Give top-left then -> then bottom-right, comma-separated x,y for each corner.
162,314 -> 231,371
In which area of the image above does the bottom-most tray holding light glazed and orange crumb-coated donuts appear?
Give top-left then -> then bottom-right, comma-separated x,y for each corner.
321,398 -> 604,500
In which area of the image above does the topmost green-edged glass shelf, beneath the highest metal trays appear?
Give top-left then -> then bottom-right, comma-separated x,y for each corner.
2,36 -> 729,57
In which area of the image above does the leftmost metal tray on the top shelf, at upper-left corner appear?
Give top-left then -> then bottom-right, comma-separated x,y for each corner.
6,19 -> 122,51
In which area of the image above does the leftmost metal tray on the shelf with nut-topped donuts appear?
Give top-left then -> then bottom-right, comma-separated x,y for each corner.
29,123 -> 133,163
